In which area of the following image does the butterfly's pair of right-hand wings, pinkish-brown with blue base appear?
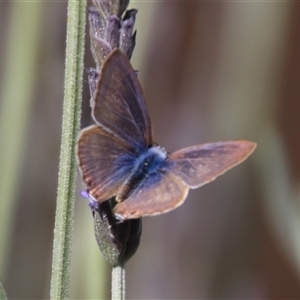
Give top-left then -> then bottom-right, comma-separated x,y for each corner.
114,141 -> 256,220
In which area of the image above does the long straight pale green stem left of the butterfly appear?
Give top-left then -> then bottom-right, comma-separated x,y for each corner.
50,0 -> 86,300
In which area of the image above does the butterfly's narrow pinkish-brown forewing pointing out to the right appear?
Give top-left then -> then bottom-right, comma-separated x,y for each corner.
166,141 -> 256,188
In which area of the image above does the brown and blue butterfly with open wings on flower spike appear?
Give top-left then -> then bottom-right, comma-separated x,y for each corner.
77,49 -> 256,221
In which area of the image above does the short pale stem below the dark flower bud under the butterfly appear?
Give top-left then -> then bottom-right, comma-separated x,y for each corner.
111,265 -> 125,300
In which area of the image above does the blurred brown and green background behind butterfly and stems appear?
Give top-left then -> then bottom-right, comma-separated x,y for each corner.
0,1 -> 300,299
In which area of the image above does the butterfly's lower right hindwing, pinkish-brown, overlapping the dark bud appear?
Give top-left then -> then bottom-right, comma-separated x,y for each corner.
114,171 -> 189,220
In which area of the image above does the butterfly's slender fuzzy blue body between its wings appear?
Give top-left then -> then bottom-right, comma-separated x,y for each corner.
117,146 -> 167,202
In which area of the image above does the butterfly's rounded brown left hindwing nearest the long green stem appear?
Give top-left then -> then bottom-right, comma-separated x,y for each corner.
77,125 -> 135,202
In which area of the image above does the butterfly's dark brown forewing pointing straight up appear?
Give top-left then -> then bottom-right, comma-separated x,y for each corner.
92,49 -> 152,151
